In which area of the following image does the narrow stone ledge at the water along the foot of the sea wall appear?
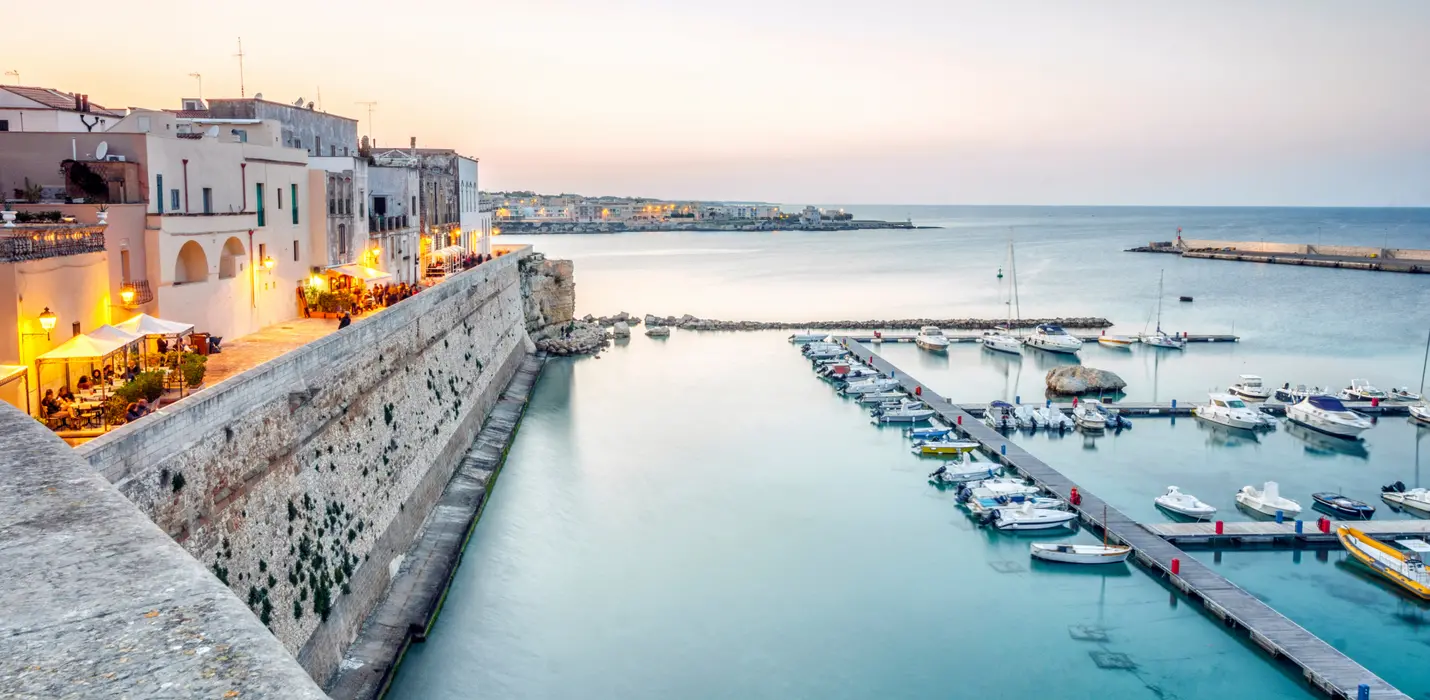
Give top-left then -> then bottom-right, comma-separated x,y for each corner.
327,353 -> 546,700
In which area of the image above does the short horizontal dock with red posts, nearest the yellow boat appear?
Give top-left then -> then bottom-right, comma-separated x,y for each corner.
1143,510 -> 1430,549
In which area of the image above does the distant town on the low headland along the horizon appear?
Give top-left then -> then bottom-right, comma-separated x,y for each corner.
482,191 -> 914,233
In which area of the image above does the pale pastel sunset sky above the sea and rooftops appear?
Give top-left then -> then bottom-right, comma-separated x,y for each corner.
8,0 -> 1430,206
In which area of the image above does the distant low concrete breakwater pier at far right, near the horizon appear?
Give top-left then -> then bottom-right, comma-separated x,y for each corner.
1127,239 -> 1430,274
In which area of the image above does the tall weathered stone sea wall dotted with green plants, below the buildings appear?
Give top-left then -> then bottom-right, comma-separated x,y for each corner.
77,250 -> 540,680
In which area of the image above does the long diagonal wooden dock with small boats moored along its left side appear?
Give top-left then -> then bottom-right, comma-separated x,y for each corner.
839,337 -> 1410,700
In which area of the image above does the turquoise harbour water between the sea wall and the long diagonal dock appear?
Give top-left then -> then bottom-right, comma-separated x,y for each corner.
393,333 -> 1310,699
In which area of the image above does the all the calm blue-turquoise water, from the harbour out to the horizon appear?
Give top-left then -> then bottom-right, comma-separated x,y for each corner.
395,207 -> 1430,699
